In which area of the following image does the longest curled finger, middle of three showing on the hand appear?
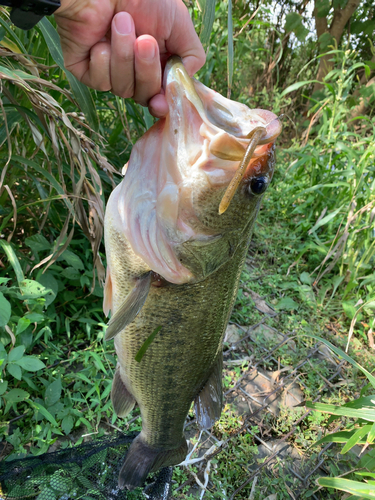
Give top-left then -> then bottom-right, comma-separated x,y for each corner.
111,12 -> 135,97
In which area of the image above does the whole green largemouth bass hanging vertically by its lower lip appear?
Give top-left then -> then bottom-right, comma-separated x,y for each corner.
104,57 -> 281,488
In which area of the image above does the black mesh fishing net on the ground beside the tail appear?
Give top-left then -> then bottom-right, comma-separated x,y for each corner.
0,433 -> 172,500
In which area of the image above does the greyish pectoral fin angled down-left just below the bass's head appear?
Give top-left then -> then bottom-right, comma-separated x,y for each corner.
105,271 -> 151,340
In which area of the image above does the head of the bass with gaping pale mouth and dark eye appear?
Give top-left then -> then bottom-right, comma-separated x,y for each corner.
118,57 -> 281,284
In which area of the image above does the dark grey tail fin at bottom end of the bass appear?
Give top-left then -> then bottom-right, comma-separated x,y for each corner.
118,434 -> 188,490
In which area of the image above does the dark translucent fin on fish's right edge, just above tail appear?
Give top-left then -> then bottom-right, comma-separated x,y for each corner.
194,352 -> 223,429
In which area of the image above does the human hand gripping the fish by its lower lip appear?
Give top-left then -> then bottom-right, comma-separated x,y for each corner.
55,0 -> 205,117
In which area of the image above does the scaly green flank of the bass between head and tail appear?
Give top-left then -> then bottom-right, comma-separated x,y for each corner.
108,225 -> 247,448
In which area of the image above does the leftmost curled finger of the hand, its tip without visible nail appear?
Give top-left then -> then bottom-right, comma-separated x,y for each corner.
76,42 -> 111,91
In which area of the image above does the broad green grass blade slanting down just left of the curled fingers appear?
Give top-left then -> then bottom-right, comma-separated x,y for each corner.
38,17 -> 99,132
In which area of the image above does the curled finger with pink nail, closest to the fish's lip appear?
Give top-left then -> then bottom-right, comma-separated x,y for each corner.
133,35 -> 161,106
